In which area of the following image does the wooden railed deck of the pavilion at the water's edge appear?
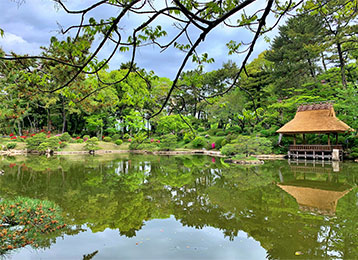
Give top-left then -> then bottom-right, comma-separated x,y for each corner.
288,144 -> 343,160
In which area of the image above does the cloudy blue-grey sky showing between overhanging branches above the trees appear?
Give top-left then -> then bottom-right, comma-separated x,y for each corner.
0,0 -> 282,79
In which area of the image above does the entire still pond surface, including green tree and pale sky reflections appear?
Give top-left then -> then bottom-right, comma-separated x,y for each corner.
0,154 -> 358,259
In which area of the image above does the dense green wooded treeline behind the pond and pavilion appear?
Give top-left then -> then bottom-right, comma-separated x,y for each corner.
0,1 -> 358,151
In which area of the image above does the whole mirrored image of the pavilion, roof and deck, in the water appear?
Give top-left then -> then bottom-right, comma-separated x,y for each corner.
277,166 -> 352,215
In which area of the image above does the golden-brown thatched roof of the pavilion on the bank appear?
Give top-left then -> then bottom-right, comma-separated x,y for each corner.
277,103 -> 353,134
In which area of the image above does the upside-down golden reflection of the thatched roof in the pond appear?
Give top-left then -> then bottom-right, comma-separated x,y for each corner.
277,184 -> 352,215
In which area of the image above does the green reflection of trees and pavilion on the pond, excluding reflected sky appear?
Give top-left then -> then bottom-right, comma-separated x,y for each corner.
0,155 -> 358,259
